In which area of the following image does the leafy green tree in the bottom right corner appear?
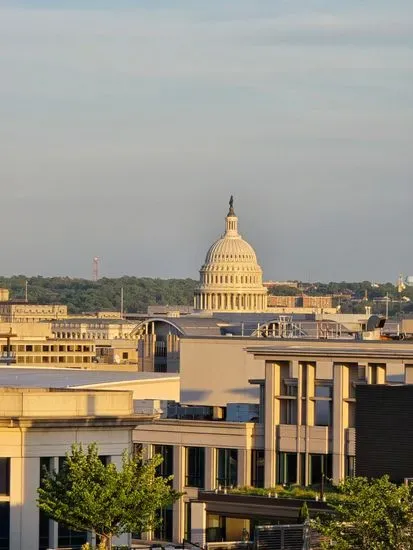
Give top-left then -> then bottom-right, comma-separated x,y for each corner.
312,476 -> 413,550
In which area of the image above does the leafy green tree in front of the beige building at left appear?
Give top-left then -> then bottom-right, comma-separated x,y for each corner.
37,443 -> 181,549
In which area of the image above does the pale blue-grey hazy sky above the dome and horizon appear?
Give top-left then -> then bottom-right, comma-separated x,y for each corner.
0,0 -> 413,282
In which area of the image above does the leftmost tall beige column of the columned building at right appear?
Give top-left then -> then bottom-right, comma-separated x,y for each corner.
264,361 -> 280,487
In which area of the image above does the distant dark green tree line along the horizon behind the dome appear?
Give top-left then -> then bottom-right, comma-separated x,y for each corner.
0,275 -> 413,315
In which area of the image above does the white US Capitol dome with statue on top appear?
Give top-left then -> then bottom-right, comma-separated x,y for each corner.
194,197 -> 267,313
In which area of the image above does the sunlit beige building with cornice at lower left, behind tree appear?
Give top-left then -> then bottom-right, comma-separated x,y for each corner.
0,388 -> 153,550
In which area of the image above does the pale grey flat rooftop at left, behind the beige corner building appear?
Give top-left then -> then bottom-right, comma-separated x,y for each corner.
0,367 -> 179,388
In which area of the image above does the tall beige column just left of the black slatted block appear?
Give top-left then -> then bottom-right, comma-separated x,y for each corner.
330,363 -> 349,483
